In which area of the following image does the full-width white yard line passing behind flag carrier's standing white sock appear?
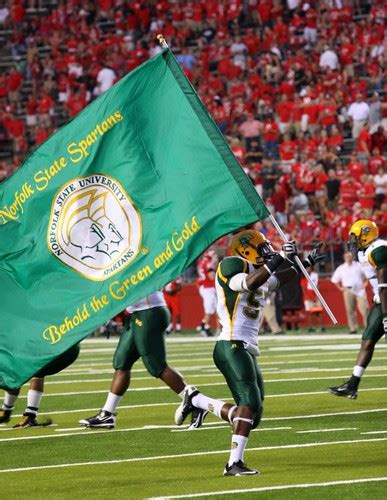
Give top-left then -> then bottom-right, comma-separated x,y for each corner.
0,437 -> 387,472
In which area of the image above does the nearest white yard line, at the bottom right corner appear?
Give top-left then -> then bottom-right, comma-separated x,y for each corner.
148,476 -> 387,500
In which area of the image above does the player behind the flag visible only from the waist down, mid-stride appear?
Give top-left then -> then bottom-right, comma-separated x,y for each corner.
79,292 -> 208,429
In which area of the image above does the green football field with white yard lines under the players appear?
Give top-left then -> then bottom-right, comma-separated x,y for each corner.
0,332 -> 387,500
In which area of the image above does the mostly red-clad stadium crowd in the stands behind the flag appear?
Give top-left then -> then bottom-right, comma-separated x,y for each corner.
0,0 -> 387,254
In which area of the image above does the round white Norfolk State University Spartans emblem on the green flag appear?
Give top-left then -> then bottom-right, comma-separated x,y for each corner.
48,174 -> 141,280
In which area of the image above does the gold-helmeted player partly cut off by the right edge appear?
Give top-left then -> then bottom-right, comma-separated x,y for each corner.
328,219 -> 387,399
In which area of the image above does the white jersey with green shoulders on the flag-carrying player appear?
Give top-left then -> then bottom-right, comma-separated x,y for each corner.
216,257 -> 270,345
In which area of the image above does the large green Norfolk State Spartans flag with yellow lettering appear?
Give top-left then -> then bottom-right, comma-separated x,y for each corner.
0,50 -> 268,389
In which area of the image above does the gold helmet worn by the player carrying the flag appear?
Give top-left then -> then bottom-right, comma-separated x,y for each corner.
230,229 -> 275,266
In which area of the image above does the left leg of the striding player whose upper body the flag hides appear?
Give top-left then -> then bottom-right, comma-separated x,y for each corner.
79,326 -> 140,429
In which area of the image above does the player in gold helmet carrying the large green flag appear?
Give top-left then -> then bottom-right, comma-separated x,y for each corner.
175,230 -> 324,476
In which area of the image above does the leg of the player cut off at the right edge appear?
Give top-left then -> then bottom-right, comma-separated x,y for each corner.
328,304 -> 384,399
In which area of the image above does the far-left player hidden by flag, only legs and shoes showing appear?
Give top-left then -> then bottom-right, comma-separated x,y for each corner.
0,344 -> 80,428
